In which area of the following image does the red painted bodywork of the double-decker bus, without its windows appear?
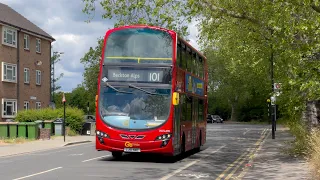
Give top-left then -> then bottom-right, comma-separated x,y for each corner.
96,25 -> 208,156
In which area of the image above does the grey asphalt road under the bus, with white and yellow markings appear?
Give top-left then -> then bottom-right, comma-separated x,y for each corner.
0,124 -> 270,180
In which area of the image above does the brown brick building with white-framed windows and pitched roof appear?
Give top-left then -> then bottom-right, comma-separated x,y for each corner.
0,3 -> 55,121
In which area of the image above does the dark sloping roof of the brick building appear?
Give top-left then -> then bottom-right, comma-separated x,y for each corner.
0,3 -> 55,41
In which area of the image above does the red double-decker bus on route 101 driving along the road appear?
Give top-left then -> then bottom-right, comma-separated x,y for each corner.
96,25 -> 208,157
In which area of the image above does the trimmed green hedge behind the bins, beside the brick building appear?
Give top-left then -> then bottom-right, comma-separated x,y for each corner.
15,107 -> 84,132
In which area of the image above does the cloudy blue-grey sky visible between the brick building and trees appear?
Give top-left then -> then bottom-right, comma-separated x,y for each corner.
0,0 -> 199,92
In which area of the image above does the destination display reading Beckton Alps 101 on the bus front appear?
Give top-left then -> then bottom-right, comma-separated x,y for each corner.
108,68 -> 164,82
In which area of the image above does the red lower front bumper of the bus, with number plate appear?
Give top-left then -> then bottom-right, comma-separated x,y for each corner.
96,136 -> 173,155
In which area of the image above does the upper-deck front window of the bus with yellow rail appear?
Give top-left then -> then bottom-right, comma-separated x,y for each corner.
104,28 -> 173,63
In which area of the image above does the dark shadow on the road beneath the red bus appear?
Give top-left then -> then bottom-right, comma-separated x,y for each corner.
99,146 -> 208,163
